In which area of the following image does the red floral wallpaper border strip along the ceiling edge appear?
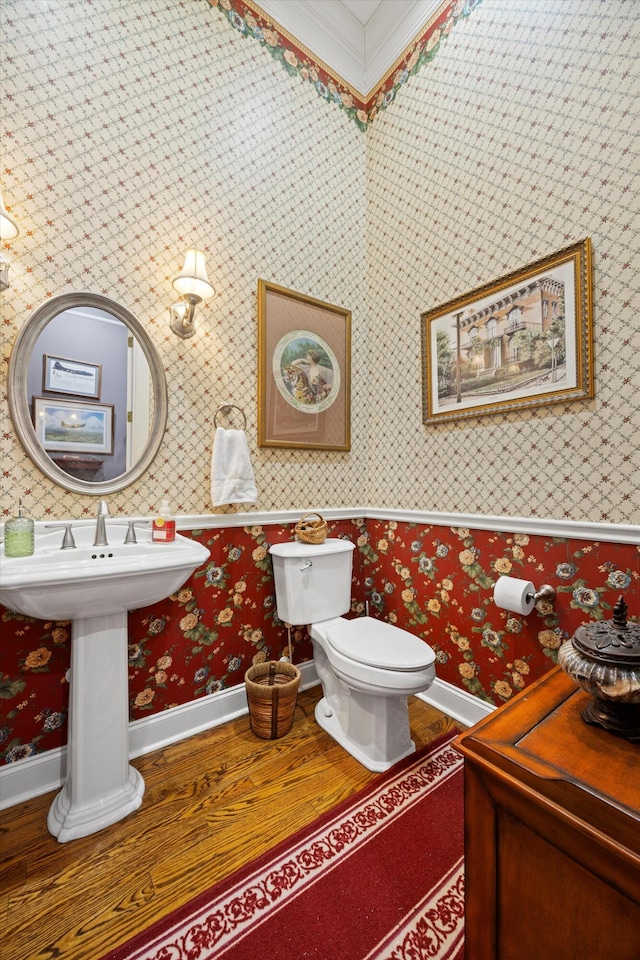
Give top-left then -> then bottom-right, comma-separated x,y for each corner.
206,0 -> 482,132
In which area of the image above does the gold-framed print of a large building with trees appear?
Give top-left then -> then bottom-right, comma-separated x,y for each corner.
420,238 -> 594,424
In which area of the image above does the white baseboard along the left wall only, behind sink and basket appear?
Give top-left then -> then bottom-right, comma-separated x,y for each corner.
0,660 -> 319,810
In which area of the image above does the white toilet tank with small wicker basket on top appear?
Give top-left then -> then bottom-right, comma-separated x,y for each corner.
269,538 -> 355,625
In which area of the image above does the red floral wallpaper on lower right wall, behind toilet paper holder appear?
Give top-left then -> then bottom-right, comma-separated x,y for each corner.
359,520 -> 640,705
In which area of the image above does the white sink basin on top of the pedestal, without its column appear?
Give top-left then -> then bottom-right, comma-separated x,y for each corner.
0,520 -> 209,620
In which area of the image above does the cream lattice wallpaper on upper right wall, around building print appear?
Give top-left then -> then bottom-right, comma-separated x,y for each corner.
366,0 -> 640,524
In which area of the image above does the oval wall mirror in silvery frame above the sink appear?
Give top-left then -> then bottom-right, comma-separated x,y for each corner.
8,293 -> 168,496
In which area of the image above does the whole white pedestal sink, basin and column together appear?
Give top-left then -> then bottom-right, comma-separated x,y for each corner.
0,520 -> 209,843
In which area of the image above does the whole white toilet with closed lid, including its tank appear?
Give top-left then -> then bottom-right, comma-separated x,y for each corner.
269,539 -> 436,772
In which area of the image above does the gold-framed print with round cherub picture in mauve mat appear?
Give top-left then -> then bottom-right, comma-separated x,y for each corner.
258,280 -> 351,450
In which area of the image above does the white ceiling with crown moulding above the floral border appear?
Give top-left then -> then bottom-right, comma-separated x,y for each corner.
257,0 -> 442,96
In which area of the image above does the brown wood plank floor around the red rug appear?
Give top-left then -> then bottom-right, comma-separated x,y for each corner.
0,686 -> 456,960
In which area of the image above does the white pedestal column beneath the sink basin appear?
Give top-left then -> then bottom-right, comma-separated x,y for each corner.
47,613 -> 144,843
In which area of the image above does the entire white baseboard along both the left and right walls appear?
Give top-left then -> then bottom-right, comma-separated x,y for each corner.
0,660 -> 496,810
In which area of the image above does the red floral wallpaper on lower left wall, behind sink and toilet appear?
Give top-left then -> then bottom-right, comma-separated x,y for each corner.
0,520 -> 365,763
